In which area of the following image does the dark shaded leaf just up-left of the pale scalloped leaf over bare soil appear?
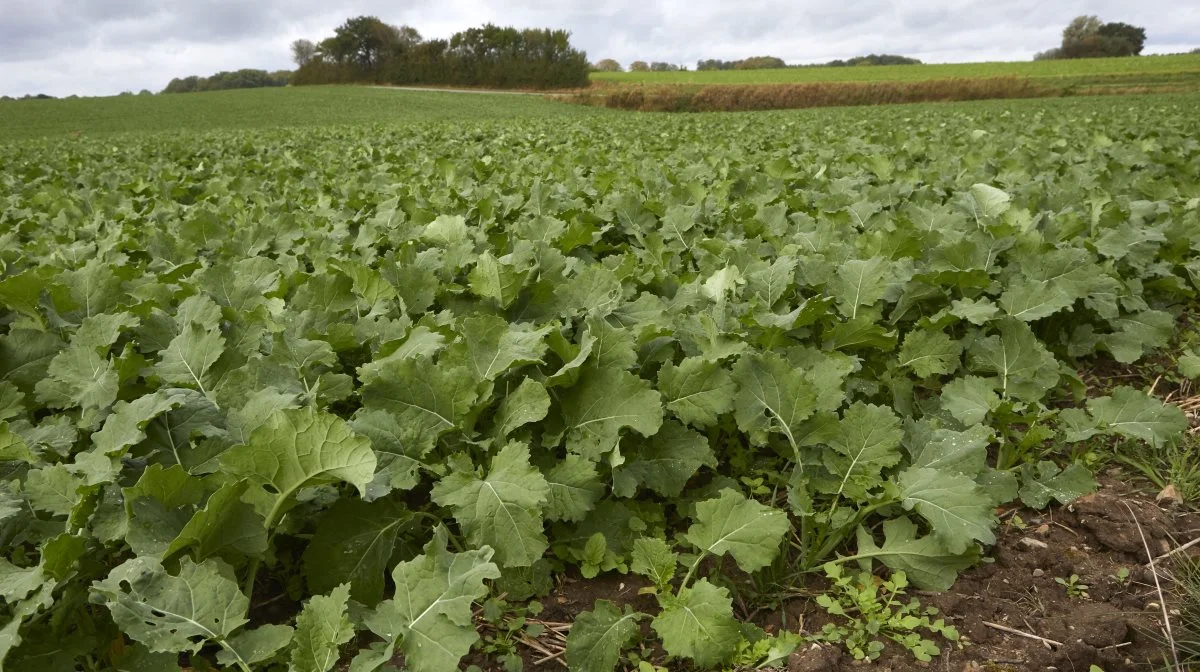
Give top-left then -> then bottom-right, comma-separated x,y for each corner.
612,420 -> 716,498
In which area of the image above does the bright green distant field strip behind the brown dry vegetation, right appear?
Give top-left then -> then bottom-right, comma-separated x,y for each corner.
592,54 -> 1200,84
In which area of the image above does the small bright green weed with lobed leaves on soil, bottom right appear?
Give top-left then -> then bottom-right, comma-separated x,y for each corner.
816,563 -> 959,662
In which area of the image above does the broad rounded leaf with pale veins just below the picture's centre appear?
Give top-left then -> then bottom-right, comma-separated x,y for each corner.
560,368 -> 662,461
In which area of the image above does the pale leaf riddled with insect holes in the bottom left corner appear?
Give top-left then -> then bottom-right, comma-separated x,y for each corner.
91,557 -> 250,653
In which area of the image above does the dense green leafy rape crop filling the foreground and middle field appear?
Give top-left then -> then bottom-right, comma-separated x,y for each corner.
0,91 -> 1200,672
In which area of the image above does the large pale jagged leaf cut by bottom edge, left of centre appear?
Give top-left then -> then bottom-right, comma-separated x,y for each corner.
350,528 -> 500,672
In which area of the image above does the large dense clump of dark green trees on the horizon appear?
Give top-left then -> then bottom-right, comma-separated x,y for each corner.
292,16 -> 588,89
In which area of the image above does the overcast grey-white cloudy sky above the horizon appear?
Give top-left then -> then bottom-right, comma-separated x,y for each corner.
0,0 -> 1200,97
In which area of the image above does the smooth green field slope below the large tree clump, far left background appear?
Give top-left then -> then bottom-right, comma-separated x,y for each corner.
0,86 -> 595,142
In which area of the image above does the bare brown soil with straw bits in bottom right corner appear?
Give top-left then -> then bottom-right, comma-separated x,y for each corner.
791,481 -> 1200,672
